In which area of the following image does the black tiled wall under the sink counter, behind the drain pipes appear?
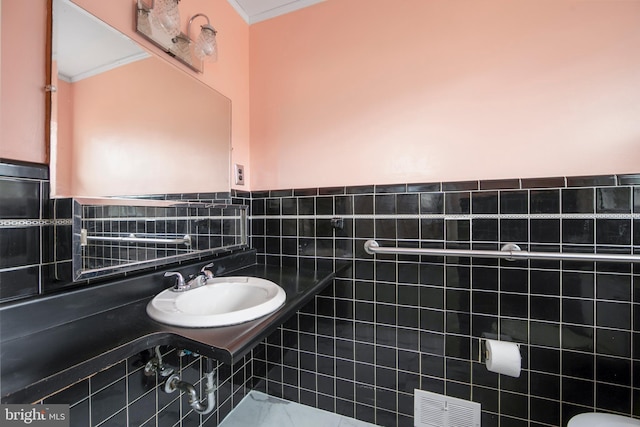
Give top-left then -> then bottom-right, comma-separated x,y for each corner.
41,346 -> 252,427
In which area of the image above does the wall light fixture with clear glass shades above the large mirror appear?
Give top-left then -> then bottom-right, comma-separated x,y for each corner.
136,0 -> 218,72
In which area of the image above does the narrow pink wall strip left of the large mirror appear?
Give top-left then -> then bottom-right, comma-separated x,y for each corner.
0,0 -> 47,163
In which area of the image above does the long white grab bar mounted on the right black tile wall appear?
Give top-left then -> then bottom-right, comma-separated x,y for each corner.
364,240 -> 640,262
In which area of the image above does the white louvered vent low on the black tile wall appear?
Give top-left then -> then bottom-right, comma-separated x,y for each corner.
413,390 -> 481,427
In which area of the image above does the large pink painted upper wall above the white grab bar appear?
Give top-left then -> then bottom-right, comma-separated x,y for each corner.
250,0 -> 640,190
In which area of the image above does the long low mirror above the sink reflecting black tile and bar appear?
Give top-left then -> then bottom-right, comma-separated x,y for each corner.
72,198 -> 248,281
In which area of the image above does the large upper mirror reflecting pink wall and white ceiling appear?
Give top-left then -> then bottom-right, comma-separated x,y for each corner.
51,0 -> 231,197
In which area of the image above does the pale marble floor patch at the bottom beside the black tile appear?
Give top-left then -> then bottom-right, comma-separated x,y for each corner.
220,391 -> 374,427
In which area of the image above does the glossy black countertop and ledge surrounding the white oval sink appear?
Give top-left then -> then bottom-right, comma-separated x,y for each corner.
0,252 -> 334,403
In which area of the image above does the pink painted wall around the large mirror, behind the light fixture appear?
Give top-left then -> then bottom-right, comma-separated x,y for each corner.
0,0 -> 249,190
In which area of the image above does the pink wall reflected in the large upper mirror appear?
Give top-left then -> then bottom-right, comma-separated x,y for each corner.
63,57 -> 231,196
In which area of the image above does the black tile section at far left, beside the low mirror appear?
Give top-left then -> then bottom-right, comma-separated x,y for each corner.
0,162 -> 71,302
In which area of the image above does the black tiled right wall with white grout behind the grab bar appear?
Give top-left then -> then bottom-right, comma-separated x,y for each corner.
247,176 -> 640,426
